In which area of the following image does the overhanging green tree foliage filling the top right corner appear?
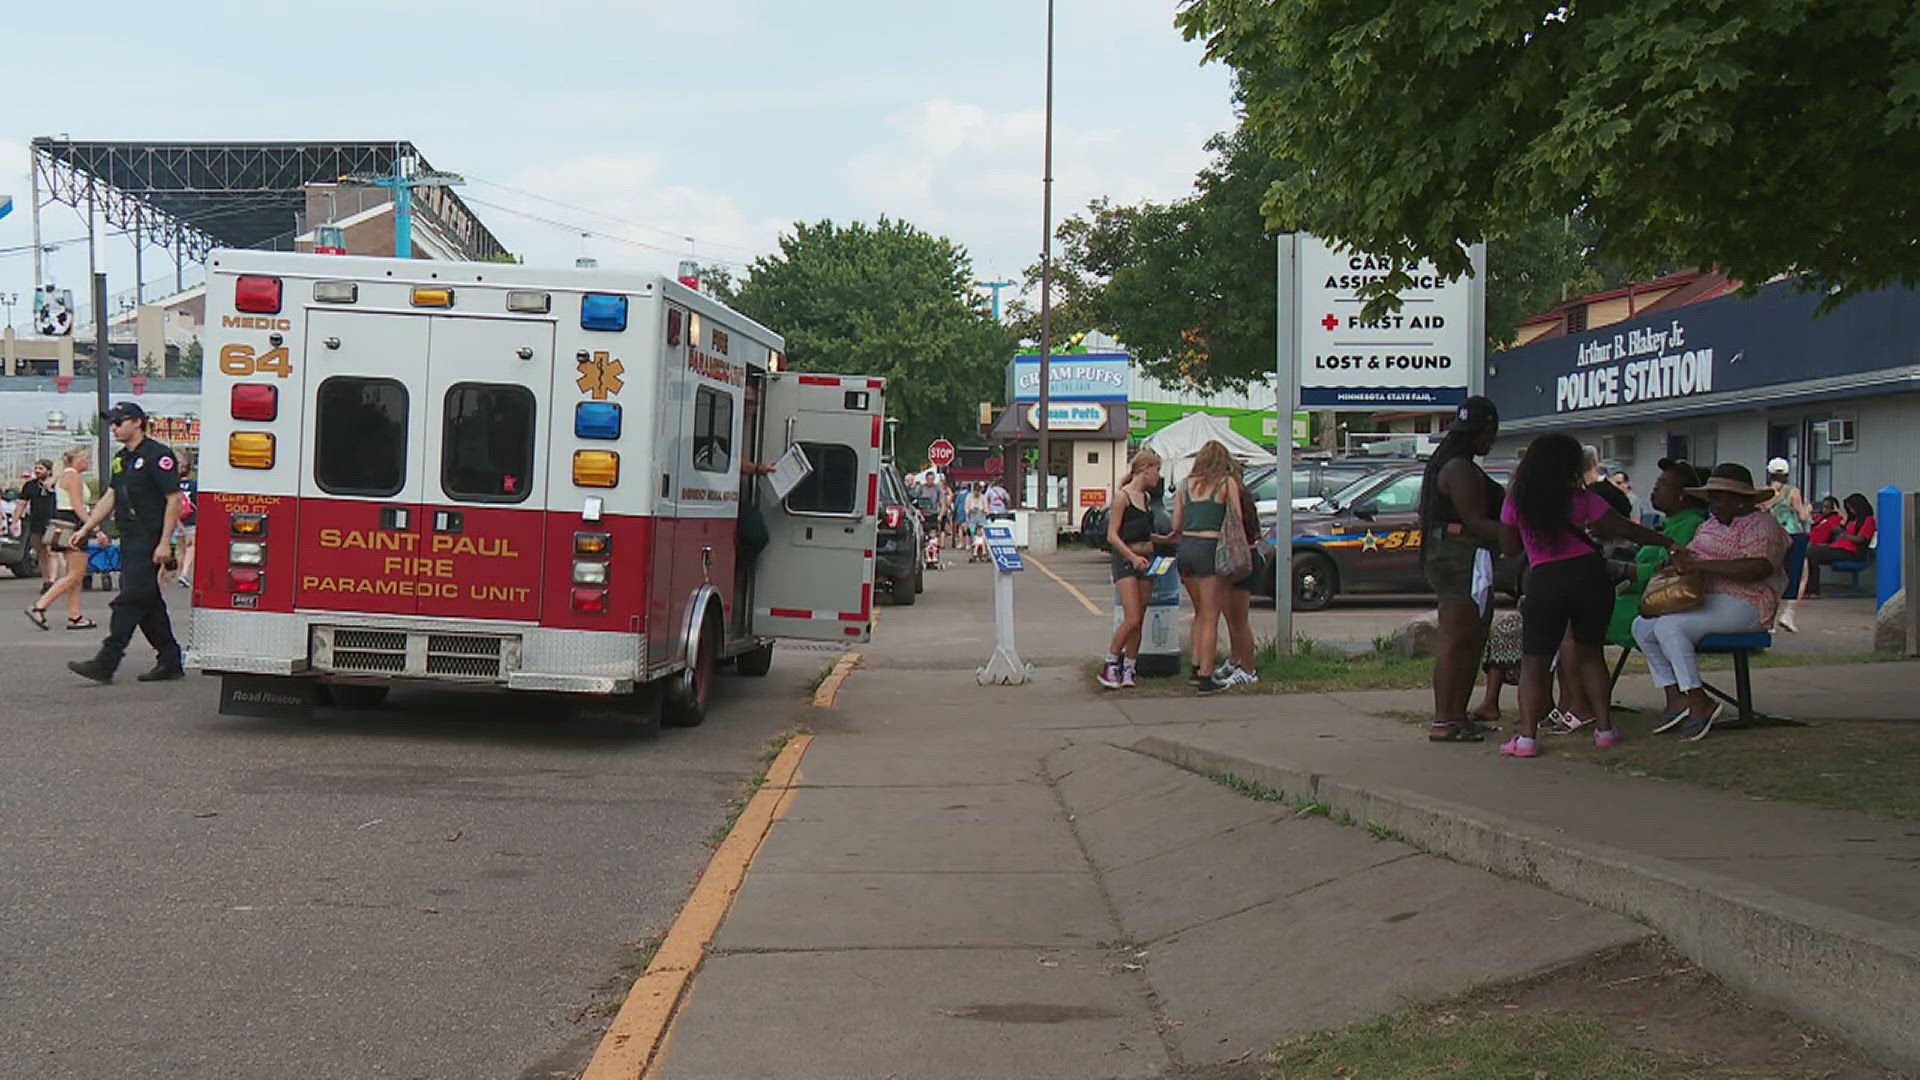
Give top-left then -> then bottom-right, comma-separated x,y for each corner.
1177,0 -> 1920,296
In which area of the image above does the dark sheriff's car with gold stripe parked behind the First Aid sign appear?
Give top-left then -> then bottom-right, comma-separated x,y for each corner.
1260,461 -> 1513,611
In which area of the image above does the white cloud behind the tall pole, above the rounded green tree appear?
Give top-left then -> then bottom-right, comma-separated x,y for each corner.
847,98 -> 1217,275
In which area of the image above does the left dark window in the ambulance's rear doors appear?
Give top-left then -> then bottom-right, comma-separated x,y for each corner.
313,375 -> 407,498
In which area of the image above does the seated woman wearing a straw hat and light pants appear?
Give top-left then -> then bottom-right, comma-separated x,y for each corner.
1634,463 -> 1789,742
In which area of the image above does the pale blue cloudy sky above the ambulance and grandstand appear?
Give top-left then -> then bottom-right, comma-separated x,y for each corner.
0,0 -> 1235,317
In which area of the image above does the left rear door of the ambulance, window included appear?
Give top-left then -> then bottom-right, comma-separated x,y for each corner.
293,309 -> 428,615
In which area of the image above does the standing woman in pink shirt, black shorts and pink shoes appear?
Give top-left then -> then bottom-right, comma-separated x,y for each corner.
1500,434 -> 1676,757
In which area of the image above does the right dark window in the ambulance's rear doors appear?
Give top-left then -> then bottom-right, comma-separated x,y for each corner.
440,382 -> 538,502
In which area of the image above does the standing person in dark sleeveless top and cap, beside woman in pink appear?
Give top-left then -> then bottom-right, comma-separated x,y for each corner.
1421,396 -> 1505,742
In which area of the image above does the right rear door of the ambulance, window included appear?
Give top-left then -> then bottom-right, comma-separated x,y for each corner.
411,315 -> 553,623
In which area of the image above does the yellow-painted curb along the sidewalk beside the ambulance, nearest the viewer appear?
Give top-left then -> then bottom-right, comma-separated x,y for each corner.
580,726 -> 814,1080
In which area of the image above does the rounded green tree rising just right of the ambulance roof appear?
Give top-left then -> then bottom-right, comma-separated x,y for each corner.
732,217 -> 1016,463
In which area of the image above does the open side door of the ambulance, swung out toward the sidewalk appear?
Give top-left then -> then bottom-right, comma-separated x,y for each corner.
751,371 -> 887,642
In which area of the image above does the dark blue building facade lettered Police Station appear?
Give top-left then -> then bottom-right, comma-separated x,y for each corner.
1486,281 -> 1920,509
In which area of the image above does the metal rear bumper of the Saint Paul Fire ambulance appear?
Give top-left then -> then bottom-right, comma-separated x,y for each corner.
186,609 -> 647,694
